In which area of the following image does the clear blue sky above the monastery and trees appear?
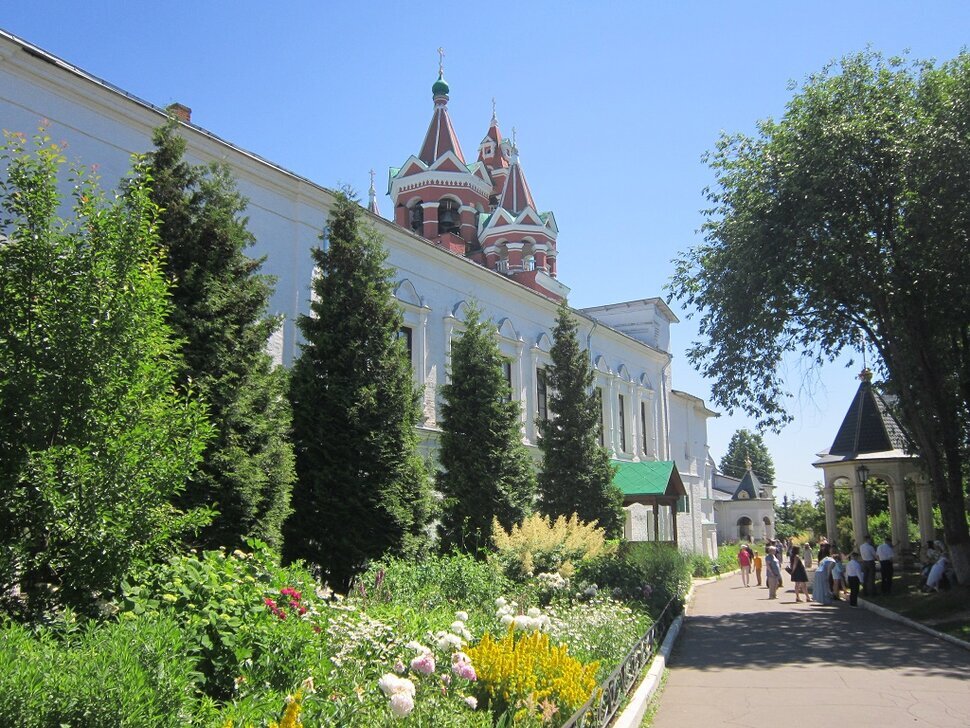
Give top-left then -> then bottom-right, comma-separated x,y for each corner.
0,0 -> 970,497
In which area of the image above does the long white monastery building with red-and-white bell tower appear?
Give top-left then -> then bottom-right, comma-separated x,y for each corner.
0,31 -> 716,555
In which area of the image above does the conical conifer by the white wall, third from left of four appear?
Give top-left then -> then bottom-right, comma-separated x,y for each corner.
438,306 -> 536,553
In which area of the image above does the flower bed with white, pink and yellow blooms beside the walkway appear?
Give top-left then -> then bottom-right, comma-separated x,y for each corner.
0,532 -> 687,728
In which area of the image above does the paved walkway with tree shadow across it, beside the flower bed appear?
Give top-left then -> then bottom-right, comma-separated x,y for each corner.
652,574 -> 970,728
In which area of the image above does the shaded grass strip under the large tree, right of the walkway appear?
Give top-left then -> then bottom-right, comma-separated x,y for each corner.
872,571 -> 970,640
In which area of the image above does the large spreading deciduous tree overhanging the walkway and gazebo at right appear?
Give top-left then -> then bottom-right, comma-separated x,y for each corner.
672,52 -> 970,583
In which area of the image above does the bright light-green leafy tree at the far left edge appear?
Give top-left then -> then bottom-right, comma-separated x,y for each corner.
0,134 -> 209,611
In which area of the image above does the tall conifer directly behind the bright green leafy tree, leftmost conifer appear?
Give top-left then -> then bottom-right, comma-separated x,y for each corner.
149,121 -> 295,548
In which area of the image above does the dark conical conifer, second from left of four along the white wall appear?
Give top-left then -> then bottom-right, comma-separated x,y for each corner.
284,193 -> 433,587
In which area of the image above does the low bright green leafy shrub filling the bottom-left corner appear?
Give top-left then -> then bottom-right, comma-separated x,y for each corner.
0,617 -> 201,728
